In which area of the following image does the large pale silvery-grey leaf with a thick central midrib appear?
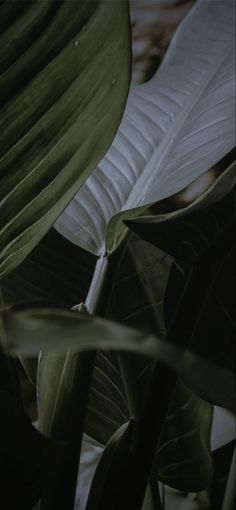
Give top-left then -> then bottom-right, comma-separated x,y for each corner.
56,0 -> 235,254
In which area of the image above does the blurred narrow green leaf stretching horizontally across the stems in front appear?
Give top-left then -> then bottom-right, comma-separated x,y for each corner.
1,308 -> 235,412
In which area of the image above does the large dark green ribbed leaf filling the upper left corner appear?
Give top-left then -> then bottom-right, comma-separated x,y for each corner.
0,0 -> 130,276
